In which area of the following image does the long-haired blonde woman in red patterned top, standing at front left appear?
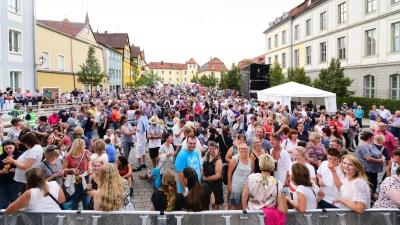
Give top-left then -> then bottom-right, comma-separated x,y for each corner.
63,139 -> 90,210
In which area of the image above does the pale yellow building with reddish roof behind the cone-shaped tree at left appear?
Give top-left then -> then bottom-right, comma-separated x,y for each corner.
36,20 -> 107,97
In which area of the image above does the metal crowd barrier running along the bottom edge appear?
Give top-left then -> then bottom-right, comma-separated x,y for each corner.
0,209 -> 400,225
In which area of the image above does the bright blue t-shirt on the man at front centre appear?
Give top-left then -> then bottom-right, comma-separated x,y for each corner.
175,149 -> 201,193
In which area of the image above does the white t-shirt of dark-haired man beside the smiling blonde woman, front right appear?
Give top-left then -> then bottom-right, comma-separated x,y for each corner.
317,161 -> 344,207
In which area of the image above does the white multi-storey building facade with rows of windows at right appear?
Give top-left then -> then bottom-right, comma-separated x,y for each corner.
266,0 -> 400,99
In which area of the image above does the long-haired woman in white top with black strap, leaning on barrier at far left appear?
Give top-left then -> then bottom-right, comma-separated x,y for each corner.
4,167 -> 65,215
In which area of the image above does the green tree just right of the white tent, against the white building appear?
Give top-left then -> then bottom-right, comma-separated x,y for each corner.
313,58 -> 354,97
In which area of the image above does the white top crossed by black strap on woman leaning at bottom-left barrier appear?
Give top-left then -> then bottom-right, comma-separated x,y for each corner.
25,181 -> 61,211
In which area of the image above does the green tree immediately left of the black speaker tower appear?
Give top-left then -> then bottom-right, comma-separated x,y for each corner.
219,63 -> 242,91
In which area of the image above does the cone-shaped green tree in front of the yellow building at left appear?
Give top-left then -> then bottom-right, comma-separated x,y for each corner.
77,46 -> 105,91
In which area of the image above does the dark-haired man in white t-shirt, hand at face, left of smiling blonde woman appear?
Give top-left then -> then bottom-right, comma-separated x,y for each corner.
317,148 -> 344,209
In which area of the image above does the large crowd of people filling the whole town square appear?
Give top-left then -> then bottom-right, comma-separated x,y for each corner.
0,86 -> 400,221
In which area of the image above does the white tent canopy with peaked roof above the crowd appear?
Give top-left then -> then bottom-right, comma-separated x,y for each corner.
257,82 -> 337,112
